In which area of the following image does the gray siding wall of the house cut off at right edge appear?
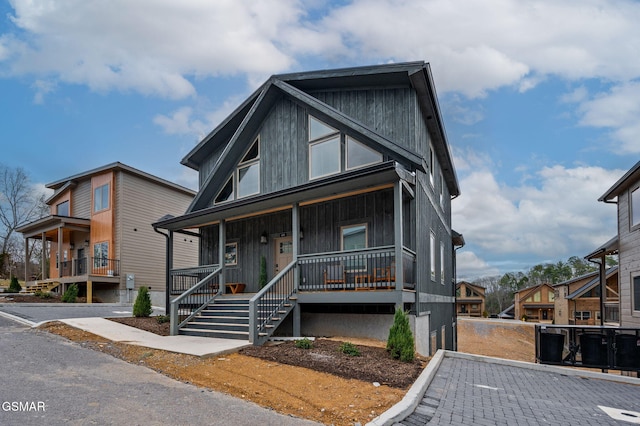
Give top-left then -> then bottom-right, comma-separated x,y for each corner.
618,182 -> 640,327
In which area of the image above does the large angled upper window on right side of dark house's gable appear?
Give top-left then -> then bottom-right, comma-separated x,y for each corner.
309,115 -> 382,179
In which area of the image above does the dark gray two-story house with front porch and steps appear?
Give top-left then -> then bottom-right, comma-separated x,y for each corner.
154,62 -> 463,354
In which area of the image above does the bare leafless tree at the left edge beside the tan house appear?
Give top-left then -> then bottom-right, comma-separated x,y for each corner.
0,164 -> 46,276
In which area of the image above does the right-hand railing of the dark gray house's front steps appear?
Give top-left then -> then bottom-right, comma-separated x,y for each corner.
249,260 -> 298,345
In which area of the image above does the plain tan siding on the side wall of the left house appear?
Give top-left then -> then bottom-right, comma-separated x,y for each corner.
116,171 -> 198,291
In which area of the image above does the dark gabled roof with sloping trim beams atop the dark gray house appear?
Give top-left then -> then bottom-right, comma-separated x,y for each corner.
181,62 -> 460,212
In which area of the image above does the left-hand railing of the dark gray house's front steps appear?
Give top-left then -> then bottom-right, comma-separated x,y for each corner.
170,267 -> 222,336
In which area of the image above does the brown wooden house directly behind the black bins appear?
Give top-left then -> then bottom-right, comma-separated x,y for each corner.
554,267 -> 619,325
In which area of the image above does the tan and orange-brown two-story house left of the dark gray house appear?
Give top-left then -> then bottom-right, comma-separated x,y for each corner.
18,162 -> 198,306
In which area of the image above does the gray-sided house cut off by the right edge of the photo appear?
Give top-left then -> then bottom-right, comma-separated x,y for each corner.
589,162 -> 640,327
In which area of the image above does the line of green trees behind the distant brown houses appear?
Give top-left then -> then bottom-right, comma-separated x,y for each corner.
473,256 -> 618,314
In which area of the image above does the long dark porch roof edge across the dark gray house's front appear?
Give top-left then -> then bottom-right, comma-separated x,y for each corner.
153,161 -> 400,231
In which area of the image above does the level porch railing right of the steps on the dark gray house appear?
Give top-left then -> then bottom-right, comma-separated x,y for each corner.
298,246 -> 415,291
